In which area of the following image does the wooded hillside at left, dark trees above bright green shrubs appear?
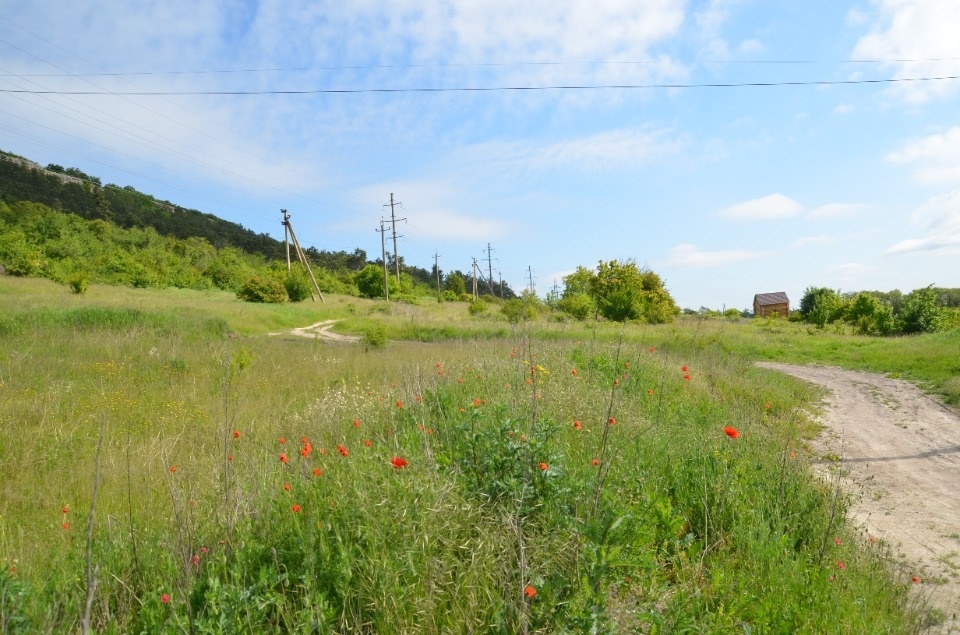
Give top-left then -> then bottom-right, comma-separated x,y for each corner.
0,151 -> 515,300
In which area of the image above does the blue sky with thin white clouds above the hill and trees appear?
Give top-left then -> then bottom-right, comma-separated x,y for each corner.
0,0 -> 960,309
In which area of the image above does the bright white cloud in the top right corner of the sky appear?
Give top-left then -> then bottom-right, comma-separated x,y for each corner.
848,0 -> 960,103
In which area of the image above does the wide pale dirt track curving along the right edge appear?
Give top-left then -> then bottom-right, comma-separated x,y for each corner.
759,363 -> 960,633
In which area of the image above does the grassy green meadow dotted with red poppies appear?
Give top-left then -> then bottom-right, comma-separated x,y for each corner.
0,277 -> 960,633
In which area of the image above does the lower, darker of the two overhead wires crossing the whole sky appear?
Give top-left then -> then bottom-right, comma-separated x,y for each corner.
0,75 -> 960,97
